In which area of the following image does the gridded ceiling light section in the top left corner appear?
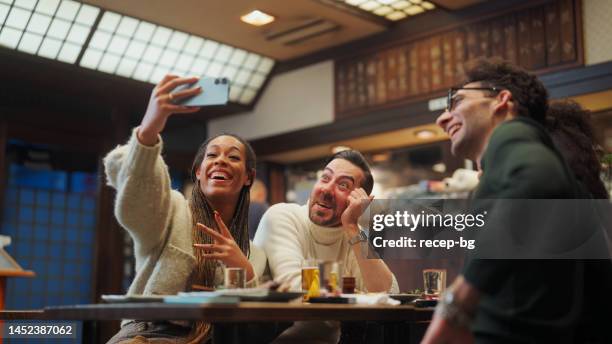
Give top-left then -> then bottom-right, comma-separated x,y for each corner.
0,0 -> 100,63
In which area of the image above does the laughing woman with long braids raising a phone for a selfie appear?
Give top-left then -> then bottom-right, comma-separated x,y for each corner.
104,75 -> 265,343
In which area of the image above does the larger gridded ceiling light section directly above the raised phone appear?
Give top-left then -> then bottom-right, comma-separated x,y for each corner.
79,10 -> 274,104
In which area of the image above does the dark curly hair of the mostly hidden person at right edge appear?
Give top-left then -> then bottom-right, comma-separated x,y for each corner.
544,100 -> 609,198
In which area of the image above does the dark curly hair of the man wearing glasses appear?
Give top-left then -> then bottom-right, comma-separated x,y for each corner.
463,59 -> 548,123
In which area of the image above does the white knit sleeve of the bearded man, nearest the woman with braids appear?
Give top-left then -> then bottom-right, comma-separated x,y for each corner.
254,203 -> 306,290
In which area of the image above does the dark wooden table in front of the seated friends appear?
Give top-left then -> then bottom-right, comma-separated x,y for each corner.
0,302 -> 433,343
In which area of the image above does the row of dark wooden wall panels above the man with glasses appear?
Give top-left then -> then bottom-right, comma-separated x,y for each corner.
335,0 -> 582,119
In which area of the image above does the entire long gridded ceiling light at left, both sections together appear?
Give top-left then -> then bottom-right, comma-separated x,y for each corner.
0,0 -> 275,104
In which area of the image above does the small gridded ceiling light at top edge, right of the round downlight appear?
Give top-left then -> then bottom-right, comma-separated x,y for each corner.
337,0 -> 436,21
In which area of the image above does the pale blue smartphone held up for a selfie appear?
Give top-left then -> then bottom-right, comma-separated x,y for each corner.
172,77 -> 229,106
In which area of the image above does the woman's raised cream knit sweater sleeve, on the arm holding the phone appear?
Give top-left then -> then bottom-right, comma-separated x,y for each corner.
104,128 -> 171,251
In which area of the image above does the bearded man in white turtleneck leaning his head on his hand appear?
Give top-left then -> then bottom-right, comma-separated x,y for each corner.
254,150 -> 399,344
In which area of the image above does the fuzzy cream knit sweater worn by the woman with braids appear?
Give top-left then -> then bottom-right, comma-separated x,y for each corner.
104,129 -> 266,295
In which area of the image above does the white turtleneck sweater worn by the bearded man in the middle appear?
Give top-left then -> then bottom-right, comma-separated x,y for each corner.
254,203 -> 399,344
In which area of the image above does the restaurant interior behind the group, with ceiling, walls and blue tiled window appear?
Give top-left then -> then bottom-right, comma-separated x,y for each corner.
0,0 -> 612,339
